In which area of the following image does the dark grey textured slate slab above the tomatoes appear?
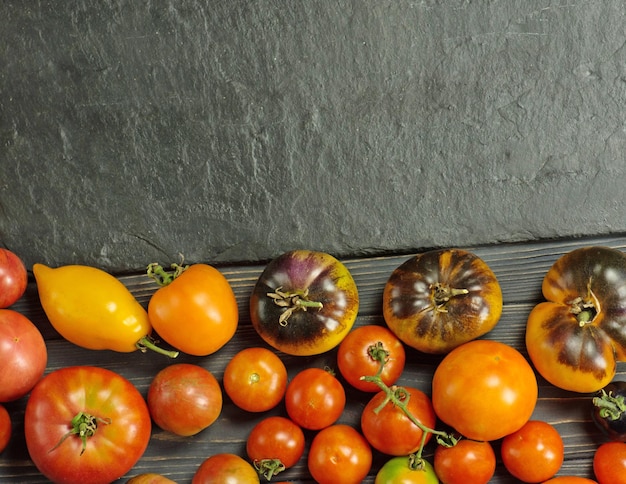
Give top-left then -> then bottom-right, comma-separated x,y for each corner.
0,0 -> 626,272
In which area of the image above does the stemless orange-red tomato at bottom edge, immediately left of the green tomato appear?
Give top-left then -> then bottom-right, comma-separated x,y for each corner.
308,424 -> 372,484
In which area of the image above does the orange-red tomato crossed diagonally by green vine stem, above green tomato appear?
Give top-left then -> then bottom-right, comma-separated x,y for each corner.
361,387 -> 436,456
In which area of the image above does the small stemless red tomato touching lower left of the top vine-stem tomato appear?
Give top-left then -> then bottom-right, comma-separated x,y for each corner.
285,368 -> 346,430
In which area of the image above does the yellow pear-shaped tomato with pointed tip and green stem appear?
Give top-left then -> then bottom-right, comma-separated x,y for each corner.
33,264 -> 177,357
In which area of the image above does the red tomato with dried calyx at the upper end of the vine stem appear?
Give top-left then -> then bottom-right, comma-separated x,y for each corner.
337,324 -> 406,392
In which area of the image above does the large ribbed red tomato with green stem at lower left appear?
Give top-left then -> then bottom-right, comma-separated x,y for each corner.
24,366 -> 151,484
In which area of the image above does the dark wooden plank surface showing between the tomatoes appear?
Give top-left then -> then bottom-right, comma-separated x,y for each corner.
0,236 -> 626,483
